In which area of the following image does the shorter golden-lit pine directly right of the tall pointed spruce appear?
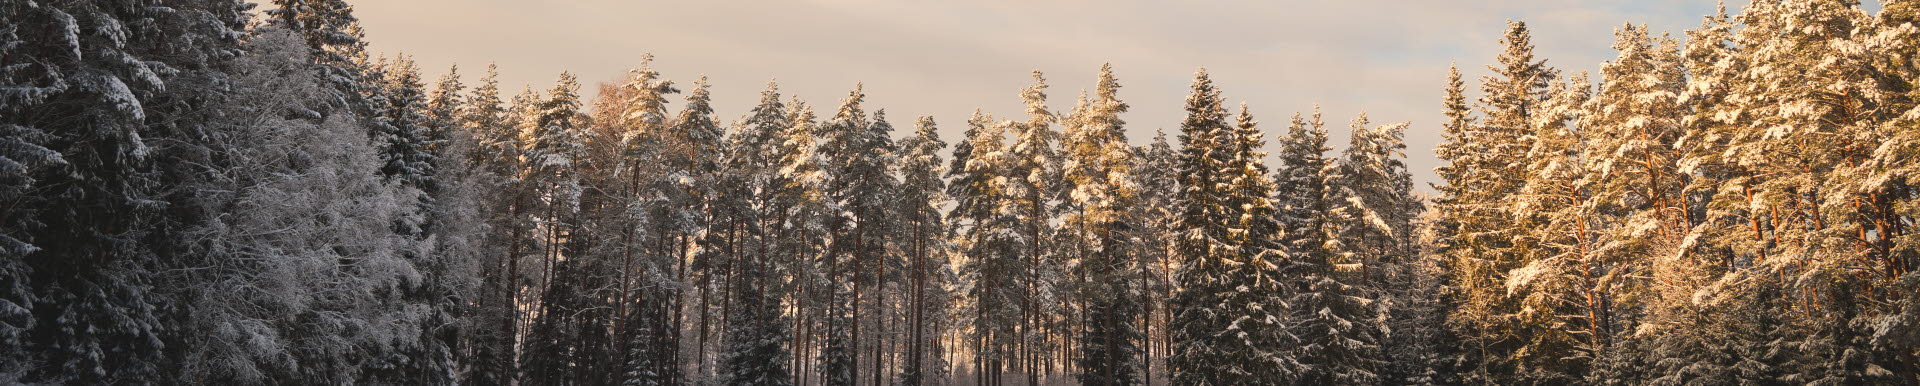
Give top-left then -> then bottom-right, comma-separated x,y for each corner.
1505,73 -> 1597,382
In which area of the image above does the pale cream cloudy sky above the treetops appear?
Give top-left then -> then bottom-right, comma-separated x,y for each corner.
326,0 -> 1743,190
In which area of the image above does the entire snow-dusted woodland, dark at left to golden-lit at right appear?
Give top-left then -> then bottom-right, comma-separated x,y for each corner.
0,0 -> 1920,386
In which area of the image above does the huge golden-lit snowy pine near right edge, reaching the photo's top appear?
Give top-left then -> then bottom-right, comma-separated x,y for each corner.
1728,0 -> 1899,382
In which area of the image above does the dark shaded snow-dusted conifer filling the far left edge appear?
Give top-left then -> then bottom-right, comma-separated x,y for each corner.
0,0 -> 246,384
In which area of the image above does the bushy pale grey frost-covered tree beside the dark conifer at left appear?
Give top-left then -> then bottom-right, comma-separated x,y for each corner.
153,29 -> 420,382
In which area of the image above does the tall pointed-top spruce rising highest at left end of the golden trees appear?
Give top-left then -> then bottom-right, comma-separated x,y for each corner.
1436,21 -> 1557,382
